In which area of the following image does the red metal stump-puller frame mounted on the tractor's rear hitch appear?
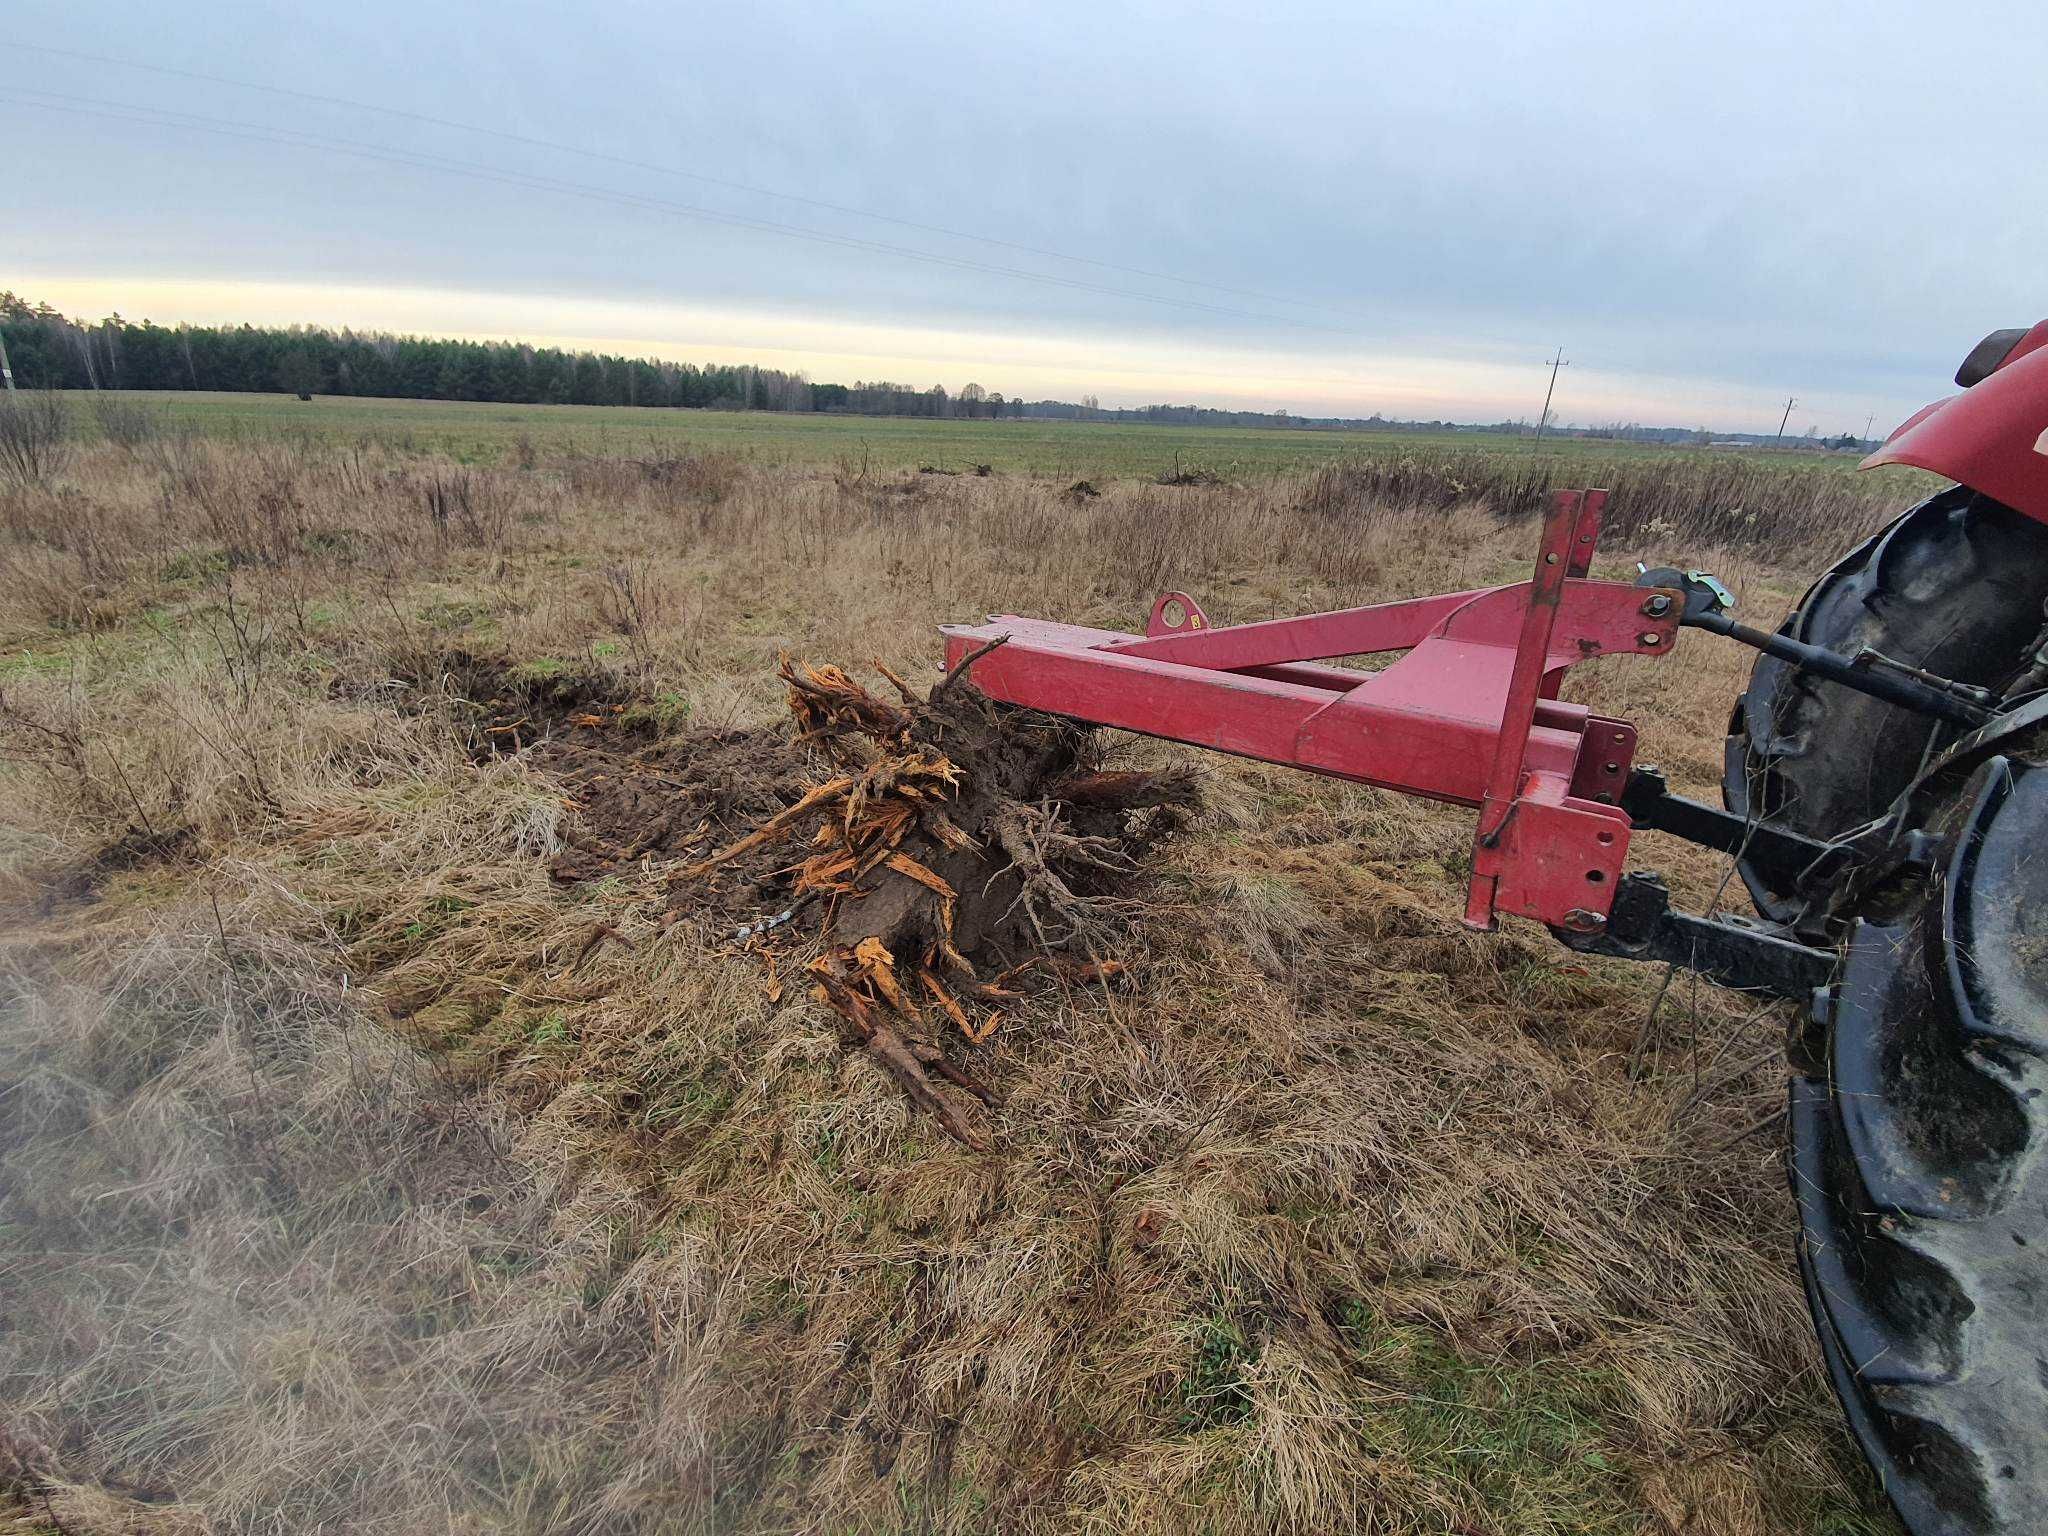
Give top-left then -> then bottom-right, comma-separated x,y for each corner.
942,492 -> 1683,932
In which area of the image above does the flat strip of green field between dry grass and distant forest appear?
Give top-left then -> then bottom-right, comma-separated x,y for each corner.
83,391 -> 1853,479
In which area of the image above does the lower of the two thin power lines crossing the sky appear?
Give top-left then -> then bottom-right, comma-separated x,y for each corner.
0,86 -> 1358,336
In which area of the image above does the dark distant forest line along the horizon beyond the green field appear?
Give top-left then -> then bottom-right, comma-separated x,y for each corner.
0,293 -> 1769,442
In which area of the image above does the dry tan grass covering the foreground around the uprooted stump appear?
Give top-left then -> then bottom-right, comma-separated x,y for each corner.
0,440 -> 1884,1536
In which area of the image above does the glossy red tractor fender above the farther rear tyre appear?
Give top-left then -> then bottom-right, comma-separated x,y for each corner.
1864,319 -> 2048,522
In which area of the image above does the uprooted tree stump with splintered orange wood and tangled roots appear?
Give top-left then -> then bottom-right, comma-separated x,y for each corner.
674,657 -> 1196,1149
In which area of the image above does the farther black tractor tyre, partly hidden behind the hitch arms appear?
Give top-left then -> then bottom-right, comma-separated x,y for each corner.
1722,485 -> 2048,938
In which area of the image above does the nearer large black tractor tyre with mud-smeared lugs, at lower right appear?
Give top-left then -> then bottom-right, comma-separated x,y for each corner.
1790,729 -> 2048,1536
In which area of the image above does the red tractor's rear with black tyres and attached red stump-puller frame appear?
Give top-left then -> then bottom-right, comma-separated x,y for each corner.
942,322 -> 2048,1536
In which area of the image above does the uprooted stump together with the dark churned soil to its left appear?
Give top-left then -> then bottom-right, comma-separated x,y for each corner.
464,643 -> 1196,1145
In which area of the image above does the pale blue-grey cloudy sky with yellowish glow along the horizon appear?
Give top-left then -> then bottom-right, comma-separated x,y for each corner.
0,0 -> 2048,434
